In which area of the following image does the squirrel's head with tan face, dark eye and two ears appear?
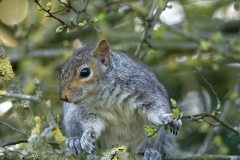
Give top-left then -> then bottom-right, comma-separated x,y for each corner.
59,40 -> 110,103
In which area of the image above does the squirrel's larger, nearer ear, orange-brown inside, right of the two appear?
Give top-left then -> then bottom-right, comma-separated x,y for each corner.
93,39 -> 110,66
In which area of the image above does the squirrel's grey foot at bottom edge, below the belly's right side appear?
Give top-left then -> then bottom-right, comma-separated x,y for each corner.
138,148 -> 162,160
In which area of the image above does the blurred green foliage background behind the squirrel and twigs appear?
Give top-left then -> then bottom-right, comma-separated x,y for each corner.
0,0 -> 240,157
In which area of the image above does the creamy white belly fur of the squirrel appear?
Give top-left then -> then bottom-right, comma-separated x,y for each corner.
94,106 -> 148,152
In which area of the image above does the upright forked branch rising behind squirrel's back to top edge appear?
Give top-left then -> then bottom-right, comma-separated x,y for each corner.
134,0 -> 170,60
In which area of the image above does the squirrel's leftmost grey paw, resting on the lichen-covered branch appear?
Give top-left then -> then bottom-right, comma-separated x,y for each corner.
66,137 -> 81,156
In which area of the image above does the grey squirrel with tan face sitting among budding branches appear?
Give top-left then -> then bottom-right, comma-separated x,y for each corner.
59,39 -> 182,160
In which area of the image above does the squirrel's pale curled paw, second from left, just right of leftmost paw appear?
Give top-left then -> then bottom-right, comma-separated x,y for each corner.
81,129 -> 96,153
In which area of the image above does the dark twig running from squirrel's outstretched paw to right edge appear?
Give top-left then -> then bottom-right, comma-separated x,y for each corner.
182,113 -> 240,137
